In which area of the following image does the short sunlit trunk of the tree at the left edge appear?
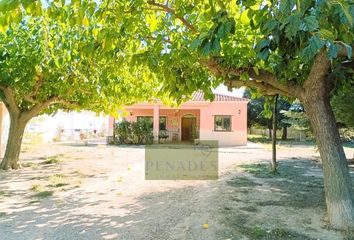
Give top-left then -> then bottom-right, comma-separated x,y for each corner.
0,113 -> 28,170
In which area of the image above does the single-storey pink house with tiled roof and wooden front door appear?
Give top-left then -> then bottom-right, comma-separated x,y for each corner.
110,91 -> 248,146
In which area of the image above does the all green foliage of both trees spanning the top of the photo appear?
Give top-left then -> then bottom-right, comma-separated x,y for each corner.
0,0 -> 354,111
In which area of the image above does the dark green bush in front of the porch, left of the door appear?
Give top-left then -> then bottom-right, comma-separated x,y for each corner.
114,119 -> 153,144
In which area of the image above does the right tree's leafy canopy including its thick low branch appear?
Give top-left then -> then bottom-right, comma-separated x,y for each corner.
0,0 -> 354,98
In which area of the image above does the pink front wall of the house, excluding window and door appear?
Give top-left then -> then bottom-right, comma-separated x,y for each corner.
112,101 -> 247,145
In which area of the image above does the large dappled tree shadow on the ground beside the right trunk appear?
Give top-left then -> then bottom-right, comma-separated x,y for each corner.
221,160 -> 354,240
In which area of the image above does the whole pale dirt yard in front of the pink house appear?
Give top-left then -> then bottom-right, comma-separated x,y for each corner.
0,143 -> 354,240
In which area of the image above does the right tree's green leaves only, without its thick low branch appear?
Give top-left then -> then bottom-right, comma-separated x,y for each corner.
90,0 -> 354,95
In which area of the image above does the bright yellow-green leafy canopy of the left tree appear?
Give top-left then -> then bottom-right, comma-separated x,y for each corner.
0,0 -> 163,115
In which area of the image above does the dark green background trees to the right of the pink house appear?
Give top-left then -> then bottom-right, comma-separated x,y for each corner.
244,86 -> 354,140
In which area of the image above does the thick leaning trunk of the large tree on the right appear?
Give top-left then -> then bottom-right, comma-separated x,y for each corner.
303,95 -> 354,229
